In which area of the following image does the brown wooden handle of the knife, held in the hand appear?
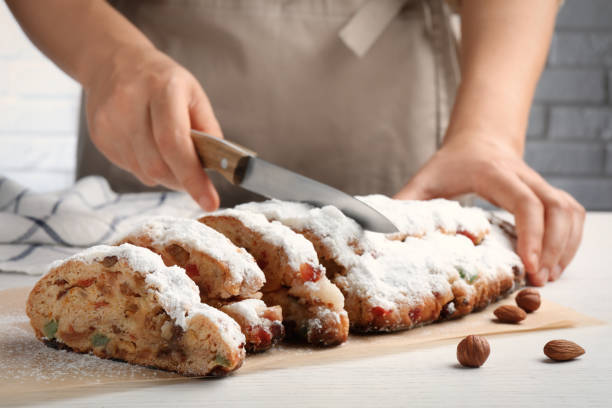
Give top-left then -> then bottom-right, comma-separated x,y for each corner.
191,129 -> 257,184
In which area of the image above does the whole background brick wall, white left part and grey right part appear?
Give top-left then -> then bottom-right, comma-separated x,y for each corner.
0,0 -> 612,210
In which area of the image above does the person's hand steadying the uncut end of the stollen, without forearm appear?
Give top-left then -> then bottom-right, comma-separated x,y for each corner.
395,135 -> 585,286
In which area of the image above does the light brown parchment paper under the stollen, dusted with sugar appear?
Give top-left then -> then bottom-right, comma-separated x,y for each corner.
0,288 -> 603,397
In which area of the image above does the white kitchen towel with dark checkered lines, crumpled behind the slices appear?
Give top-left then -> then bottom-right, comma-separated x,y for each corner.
0,176 -> 202,275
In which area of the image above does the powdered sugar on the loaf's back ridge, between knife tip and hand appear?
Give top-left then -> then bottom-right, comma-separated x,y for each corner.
356,194 -> 490,236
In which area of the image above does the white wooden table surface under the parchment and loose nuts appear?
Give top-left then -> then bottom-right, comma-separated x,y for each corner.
0,213 -> 612,408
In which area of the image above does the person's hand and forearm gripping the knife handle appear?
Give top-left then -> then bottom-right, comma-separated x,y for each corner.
7,0 -> 222,210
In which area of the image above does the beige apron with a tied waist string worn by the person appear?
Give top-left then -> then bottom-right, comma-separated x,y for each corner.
77,0 -> 456,206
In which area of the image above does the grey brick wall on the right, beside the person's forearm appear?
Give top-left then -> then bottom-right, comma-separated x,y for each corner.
525,0 -> 612,210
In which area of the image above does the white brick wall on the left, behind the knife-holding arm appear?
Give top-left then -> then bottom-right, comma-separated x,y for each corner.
0,1 -> 80,191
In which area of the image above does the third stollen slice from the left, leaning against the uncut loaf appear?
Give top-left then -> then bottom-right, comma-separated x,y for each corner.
200,209 -> 348,346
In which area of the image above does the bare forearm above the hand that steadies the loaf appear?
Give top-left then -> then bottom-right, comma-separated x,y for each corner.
445,0 -> 558,154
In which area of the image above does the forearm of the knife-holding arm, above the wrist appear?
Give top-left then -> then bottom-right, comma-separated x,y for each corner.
7,0 -> 153,84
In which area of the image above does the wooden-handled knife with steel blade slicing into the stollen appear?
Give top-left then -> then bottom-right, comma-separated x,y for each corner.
191,130 -> 397,233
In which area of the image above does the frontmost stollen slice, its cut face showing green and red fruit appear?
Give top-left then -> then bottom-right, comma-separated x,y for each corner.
26,244 -> 245,376
